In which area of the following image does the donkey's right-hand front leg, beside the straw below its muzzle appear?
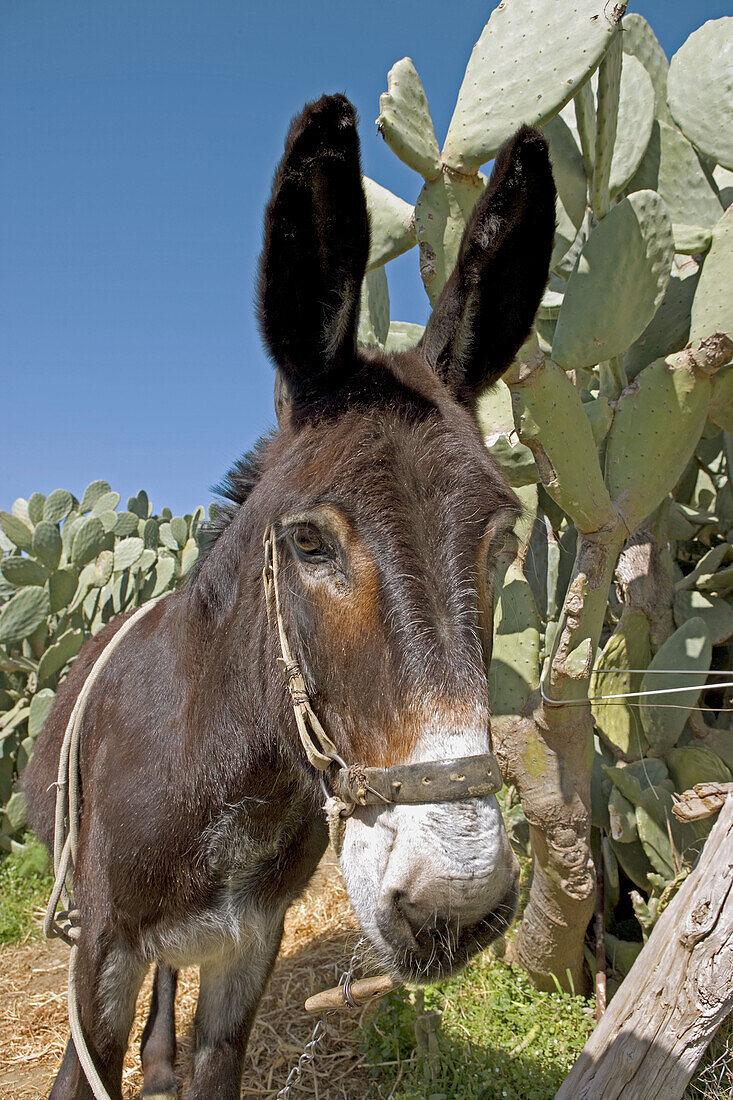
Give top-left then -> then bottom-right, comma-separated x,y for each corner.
187,913 -> 283,1100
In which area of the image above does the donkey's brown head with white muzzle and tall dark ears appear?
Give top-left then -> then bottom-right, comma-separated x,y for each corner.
208,96 -> 555,980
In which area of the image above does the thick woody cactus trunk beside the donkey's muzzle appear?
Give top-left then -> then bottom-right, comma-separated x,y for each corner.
493,526 -> 624,993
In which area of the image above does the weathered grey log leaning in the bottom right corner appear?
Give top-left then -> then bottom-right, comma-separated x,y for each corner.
555,798 -> 733,1100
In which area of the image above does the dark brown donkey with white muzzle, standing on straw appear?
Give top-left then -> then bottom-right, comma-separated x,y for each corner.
25,96 -> 555,1100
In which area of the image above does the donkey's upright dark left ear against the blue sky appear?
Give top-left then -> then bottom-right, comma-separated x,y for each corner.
259,96 -> 369,403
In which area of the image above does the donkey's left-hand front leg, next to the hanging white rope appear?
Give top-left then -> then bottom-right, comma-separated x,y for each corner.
50,937 -> 147,1100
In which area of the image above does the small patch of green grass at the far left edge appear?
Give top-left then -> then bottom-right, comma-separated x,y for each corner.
0,834 -> 52,946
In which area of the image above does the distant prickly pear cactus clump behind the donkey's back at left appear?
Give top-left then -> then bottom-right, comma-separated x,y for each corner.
0,481 -> 204,850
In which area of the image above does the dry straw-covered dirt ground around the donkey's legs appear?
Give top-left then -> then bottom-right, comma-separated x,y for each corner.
0,853 -> 375,1100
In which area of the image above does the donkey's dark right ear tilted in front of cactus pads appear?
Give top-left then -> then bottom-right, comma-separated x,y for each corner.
420,127 -> 555,404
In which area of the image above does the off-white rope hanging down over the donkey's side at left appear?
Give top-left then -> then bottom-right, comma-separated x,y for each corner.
43,600 -> 157,1100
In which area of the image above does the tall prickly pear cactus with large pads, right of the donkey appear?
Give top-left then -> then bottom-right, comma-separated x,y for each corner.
362,0 -> 733,970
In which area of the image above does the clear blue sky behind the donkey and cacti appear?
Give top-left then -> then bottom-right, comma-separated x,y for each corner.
0,0 -> 730,513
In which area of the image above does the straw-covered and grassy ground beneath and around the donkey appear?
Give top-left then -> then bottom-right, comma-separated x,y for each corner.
0,842 -> 733,1100
